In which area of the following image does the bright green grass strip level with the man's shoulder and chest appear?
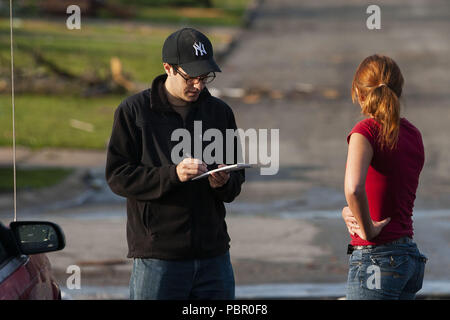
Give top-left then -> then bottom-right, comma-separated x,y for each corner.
0,95 -> 125,149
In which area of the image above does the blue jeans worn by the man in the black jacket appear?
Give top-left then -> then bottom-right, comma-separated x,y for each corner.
130,252 -> 235,300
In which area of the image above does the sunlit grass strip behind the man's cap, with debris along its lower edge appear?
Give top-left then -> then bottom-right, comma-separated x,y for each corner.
0,19 -> 229,83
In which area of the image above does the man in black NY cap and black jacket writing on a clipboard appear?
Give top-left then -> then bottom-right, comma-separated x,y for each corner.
106,28 -> 245,300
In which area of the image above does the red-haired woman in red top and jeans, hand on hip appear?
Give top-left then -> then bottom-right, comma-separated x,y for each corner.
342,55 -> 426,299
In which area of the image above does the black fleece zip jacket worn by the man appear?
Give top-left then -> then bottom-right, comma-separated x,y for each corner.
105,75 -> 245,260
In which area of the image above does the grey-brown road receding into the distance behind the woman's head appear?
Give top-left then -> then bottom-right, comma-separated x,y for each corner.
213,0 -> 450,208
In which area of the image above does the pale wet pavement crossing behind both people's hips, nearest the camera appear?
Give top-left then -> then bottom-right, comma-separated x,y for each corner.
5,203 -> 450,299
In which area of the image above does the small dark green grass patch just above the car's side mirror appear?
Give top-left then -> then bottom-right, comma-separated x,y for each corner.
0,167 -> 73,192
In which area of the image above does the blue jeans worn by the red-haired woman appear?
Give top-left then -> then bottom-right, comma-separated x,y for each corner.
347,241 -> 427,300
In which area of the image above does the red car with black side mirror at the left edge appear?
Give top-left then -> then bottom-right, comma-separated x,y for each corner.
0,221 -> 65,300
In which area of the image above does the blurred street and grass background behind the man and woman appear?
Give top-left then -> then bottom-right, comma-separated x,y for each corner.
0,0 -> 450,299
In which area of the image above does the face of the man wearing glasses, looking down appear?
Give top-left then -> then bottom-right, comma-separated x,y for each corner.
166,66 -> 205,102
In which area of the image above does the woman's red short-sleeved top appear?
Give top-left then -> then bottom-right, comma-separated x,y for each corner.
347,118 -> 425,246
